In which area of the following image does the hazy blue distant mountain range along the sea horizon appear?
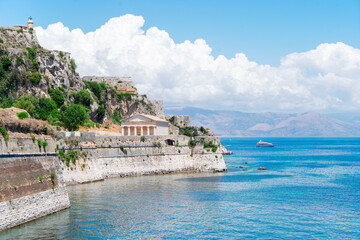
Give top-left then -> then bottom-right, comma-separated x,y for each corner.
165,107 -> 360,137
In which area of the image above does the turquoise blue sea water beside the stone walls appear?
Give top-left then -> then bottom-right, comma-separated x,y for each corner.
0,138 -> 360,239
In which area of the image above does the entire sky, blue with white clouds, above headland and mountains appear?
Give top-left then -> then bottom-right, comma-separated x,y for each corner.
0,0 -> 360,113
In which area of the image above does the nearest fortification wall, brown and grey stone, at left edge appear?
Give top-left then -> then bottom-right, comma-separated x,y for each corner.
0,135 -> 70,231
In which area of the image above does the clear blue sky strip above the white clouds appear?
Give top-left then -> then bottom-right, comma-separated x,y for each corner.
0,0 -> 360,66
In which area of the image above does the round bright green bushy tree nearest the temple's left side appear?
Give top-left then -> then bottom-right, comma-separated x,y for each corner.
61,104 -> 88,130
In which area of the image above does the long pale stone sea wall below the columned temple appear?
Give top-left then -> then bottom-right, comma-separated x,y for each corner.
59,135 -> 226,184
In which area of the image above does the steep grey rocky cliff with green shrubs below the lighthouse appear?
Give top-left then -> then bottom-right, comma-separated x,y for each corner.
0,27 -> 165,127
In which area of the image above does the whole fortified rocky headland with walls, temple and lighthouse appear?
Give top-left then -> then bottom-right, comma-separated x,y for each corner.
0,18 -> 229,231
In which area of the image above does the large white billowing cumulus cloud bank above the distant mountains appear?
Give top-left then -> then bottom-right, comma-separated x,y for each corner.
35,14 -> 360,111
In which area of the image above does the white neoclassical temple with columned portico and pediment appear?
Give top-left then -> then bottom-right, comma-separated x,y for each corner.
121,114 -> 169,136
